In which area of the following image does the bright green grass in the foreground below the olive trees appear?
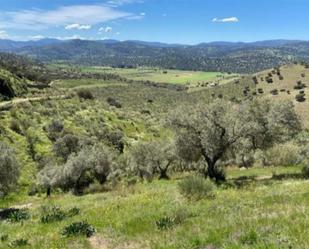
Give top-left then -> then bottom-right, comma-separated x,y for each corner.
0,167 -> 309,249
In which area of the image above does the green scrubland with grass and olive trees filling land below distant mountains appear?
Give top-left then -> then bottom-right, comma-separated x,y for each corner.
0,55 -> 309,249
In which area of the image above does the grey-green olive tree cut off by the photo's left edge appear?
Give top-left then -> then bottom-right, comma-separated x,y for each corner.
0,142 -> 19,197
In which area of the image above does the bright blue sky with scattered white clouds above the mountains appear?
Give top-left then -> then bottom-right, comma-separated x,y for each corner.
0,0 -> 309,44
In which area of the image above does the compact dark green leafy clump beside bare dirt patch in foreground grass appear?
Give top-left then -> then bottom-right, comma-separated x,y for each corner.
62,221 -> 95,238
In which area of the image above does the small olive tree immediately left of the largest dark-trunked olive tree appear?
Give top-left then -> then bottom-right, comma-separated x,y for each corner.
132,140 -> 176,179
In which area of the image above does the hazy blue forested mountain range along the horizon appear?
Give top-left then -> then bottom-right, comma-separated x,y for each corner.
0,39 -> 309,73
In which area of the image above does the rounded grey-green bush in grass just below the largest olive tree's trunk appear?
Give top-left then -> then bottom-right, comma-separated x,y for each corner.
178,176 -> 215,200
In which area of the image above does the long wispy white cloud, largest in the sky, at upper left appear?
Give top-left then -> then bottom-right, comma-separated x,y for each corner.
0,5 -> 135,30
